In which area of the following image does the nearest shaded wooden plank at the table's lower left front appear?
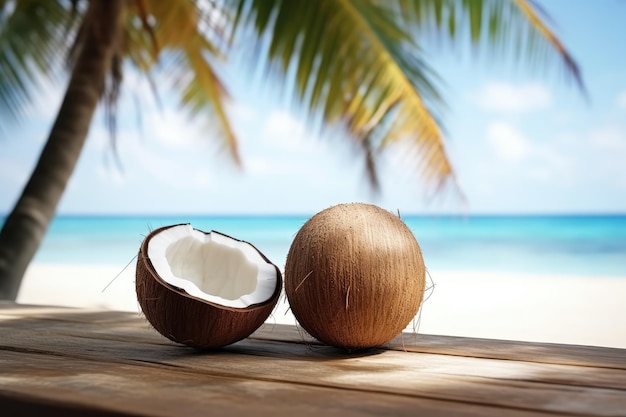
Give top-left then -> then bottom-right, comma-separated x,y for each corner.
0,352 -> 553,417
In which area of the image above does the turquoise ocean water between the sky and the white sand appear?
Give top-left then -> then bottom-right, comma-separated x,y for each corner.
6,215 -> 626,277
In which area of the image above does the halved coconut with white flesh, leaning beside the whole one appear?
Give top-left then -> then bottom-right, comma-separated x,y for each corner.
136,224 -> 282,349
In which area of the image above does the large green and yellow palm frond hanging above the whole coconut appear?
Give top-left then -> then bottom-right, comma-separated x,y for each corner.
229,0 -> 452,186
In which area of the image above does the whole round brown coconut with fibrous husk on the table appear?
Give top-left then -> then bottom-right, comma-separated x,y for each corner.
285,203 -> 426,349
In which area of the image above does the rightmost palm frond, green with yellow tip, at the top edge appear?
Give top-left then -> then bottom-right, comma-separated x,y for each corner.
399,0 -> 586,95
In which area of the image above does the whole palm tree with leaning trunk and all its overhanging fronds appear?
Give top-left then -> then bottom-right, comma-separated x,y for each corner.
0,0 -> 582,299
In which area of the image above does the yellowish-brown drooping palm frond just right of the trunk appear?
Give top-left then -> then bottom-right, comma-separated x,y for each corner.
125,0 -> 241,164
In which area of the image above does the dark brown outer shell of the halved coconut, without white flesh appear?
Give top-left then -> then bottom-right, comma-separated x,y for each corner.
135,226 -> 282,349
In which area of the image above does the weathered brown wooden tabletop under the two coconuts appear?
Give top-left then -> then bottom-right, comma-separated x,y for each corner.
0,303 -> 626,417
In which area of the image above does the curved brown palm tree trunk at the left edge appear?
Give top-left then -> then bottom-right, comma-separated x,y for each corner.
0,0 -> 124,300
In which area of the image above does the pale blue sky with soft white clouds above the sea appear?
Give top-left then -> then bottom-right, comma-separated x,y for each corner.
0,0 -> 626,215
